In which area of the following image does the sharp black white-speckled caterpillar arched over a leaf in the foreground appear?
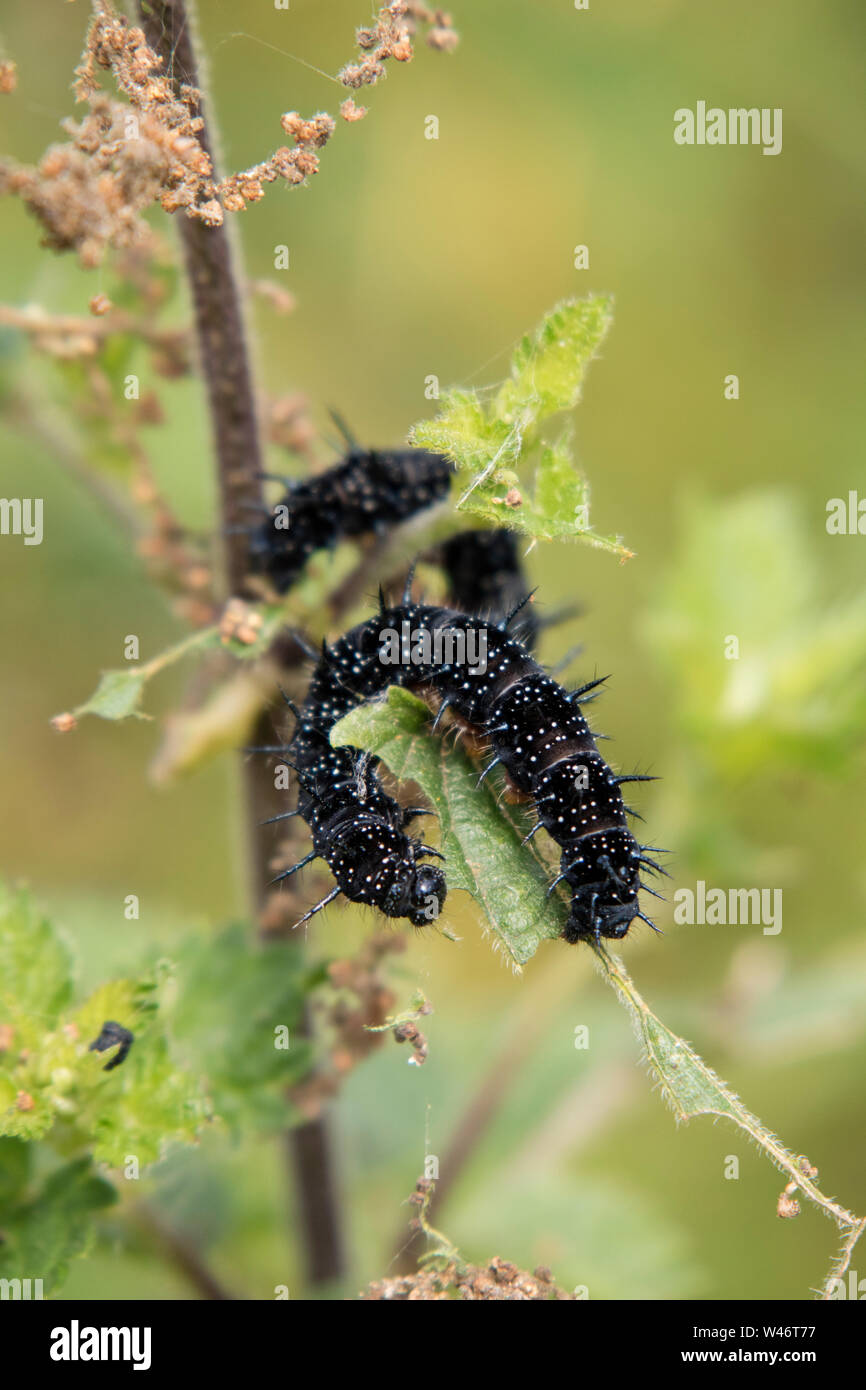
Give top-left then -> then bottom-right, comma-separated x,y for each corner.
275,587 -> 664,942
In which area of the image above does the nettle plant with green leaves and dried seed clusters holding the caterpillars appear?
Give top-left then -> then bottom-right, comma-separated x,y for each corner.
0,0 -> 863,1298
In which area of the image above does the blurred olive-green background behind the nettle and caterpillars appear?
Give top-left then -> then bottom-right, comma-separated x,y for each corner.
0,0 -> 866,1298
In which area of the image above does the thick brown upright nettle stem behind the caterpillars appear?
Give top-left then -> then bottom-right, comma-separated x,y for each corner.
138,0 -> 345,1283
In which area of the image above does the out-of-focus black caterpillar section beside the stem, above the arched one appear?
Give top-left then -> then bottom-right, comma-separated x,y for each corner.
249,448 -> 453,594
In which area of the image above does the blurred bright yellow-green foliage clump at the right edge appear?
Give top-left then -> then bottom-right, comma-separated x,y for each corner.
642,491 -> 866,881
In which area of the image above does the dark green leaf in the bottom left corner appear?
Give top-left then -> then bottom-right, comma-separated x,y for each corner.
0,1158 -> 117,1297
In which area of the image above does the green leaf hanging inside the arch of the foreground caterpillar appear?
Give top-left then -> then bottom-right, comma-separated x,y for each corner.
331,687 -> 564,966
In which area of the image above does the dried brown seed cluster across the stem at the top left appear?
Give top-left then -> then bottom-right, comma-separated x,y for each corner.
0,0 -> 456,267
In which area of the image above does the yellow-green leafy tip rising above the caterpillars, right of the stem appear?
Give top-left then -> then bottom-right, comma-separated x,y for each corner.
410,296 -> 632,559
